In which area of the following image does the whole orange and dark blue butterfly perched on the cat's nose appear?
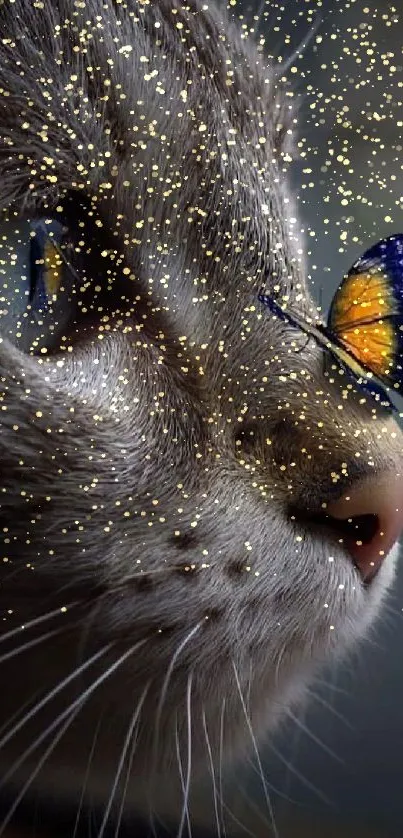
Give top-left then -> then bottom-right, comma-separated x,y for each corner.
258,234 -> 403,410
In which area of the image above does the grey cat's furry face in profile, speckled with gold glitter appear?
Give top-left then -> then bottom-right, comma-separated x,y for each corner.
0,0 -> 402,828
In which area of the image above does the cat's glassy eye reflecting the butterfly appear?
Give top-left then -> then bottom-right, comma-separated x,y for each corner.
0,216 -> 77,354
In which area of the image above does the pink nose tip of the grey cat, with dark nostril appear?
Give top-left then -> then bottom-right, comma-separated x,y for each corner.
326,471 -> 403,583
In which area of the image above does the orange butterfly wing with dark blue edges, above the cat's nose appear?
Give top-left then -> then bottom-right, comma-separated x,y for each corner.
328,235 -> 403,390
